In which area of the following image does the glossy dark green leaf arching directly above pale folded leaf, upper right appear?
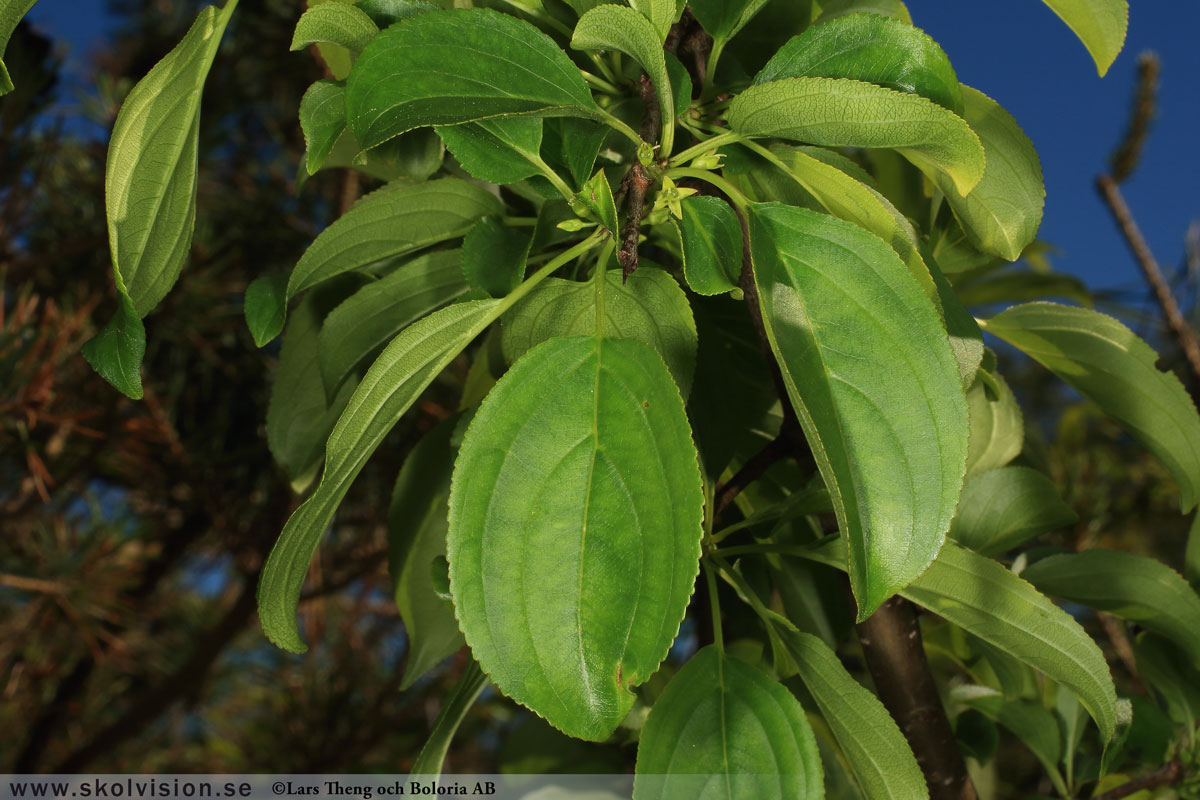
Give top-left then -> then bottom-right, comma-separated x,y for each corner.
754,13 -> 970,115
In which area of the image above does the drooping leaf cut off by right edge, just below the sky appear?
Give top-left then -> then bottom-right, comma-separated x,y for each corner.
984,302 -> 1200,512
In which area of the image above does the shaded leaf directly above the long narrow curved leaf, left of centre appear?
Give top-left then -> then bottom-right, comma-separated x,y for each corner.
317,249 -> 467,396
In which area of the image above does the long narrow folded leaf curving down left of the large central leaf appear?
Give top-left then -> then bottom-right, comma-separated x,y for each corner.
258,300 -> 502,652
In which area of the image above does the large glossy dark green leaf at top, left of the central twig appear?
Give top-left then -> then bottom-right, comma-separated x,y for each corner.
346,8 -> 598,149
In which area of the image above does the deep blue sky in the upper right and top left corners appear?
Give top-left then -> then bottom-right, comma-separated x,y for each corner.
21,0 -> 1200,288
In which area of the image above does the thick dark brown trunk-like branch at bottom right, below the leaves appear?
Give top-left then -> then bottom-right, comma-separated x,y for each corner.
858,597 -> 977,800
